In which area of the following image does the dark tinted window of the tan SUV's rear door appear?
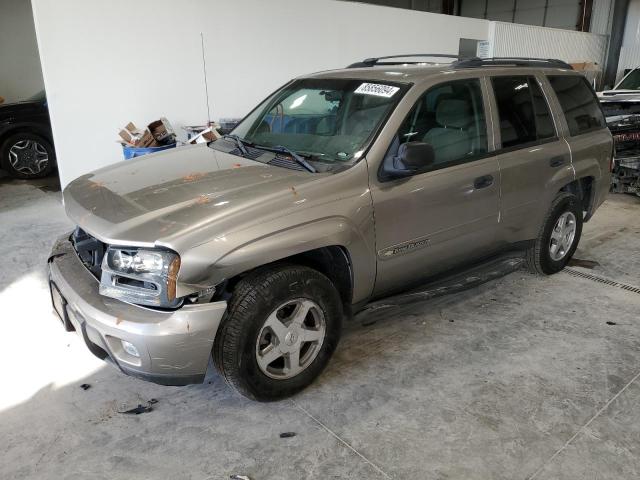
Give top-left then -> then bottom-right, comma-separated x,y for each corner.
491,76 -> 555,148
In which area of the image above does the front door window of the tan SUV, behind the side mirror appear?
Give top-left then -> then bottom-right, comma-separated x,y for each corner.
392,79 -> 487,170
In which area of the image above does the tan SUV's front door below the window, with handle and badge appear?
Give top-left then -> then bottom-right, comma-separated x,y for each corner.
371,158 -> 499,294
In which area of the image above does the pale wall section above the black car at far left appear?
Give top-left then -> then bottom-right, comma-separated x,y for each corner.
0,0 -> 44,103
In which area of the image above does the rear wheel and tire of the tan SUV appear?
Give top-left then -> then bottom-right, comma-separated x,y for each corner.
525,193 -> 583,275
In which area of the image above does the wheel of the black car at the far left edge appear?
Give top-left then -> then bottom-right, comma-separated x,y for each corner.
0,132 -> 56,179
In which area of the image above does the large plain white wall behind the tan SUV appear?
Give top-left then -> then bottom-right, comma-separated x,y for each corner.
33,0 -> 488,185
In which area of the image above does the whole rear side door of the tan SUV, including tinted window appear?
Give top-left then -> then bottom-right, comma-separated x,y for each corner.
489,73 -> 573,243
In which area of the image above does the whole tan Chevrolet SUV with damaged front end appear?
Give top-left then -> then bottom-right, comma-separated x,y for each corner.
49,55 -> 612,400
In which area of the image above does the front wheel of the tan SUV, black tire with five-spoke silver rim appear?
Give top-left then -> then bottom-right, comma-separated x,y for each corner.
213,265 -> 343,402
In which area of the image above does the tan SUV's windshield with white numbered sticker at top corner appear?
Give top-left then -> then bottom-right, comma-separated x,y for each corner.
232,79 -> 406,163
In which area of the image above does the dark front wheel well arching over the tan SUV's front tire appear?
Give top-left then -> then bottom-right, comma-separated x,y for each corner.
216,245 -> 353,312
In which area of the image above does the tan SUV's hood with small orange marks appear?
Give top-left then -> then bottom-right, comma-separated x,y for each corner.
63,144 -> 326,246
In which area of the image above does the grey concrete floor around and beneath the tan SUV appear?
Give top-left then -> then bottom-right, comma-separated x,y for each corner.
0,173 -> 640,480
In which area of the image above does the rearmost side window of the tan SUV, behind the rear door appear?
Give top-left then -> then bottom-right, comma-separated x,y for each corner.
548,75 -> 605,136
